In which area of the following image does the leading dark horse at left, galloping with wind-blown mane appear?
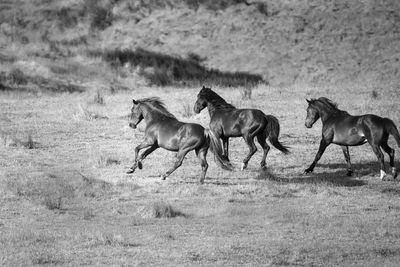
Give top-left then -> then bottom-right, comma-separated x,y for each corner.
127,97 -> 232,183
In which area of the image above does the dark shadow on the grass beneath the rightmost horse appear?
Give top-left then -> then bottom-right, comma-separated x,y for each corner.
257,161 -> 389,187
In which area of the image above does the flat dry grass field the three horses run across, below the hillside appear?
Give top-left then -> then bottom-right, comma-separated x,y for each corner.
0,82 -> 400,266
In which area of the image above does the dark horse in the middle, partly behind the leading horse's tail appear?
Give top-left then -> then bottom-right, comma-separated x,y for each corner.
193,86 -> 289,170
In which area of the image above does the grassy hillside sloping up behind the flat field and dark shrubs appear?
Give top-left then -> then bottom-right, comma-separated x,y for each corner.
0,0 -> 400,90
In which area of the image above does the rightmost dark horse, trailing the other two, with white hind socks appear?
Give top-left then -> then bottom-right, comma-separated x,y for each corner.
305,97 -> 400,179
